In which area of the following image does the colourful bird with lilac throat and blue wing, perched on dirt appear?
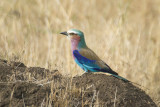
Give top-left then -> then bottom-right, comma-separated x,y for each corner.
60,29 -> 129,82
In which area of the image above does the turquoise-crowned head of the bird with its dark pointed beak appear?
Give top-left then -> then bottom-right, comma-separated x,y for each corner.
60,29 -> 86,48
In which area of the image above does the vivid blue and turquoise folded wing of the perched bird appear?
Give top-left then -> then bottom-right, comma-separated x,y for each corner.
73,50 -> 118,75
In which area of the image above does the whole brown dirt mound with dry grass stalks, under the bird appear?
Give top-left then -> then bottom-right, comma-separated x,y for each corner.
0,60 -> 156,107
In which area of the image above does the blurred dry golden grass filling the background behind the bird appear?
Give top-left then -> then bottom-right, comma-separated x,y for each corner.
0,0 -> 160,105
